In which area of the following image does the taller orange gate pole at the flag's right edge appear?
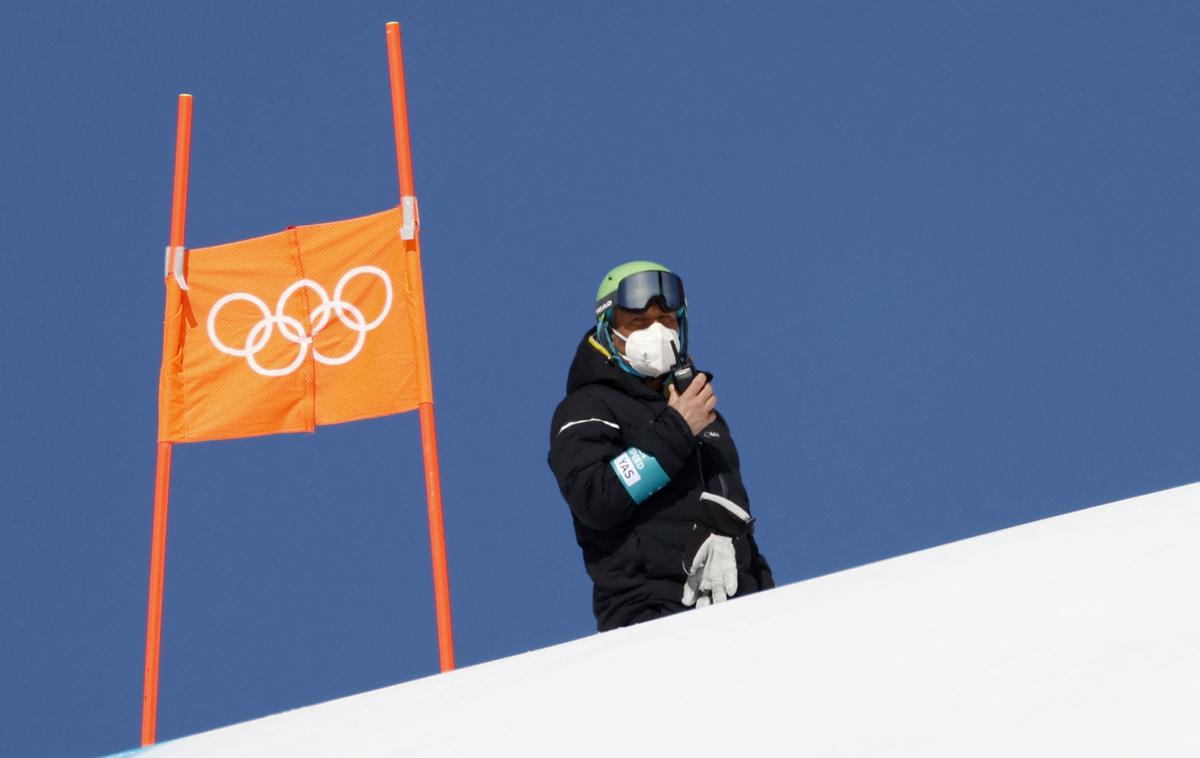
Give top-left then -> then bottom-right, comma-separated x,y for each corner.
388,22 -> 454,672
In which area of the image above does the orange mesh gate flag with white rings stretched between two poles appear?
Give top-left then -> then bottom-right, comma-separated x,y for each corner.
158,207 -> 432,443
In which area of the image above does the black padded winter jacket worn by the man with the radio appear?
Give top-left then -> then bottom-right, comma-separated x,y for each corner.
550,330 -> 775,631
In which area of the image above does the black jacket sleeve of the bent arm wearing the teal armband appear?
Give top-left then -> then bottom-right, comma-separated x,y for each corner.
548,396 -> 696,531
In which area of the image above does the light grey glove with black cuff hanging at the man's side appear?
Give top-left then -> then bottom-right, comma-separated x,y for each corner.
680,492 -> 752,608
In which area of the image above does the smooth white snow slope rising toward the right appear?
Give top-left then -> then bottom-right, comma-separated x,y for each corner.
138,483 -> 1200,758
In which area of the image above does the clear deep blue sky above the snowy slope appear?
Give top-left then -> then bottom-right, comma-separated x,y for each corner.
0,1 -> 1200,756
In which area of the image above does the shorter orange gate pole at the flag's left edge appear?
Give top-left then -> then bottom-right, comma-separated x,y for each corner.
142,94 -> 192,745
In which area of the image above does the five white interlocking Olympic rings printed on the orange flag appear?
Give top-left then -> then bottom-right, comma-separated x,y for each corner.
208,266 -> 391,377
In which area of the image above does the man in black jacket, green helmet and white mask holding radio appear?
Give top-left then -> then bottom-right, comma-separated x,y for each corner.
550,260 -> 774,631
